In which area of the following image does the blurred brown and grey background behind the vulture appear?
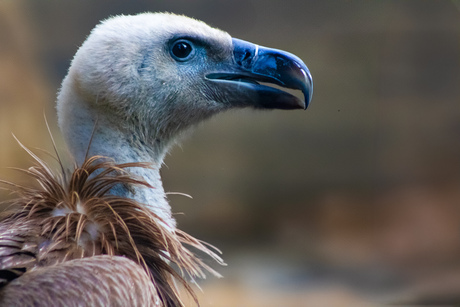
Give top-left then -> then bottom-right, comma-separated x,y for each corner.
0,0 -> 460,307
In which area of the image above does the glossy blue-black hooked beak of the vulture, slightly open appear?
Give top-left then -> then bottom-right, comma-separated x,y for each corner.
206,38 -> 313,110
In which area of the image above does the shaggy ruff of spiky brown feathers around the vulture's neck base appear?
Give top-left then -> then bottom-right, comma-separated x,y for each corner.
0,150 -> 223,306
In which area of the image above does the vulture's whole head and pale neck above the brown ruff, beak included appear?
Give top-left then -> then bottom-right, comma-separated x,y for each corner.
57,13 -> 312,229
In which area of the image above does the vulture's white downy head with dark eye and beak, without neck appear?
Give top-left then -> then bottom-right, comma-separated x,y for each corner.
67,13 -> 312,138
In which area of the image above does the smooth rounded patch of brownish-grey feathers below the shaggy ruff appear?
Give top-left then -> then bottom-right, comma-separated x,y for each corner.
0,255 -> 164,307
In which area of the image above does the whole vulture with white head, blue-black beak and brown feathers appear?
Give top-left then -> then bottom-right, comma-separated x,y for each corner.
0,13 -> 313,306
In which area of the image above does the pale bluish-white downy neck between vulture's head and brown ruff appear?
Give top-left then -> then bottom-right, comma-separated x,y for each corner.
57,78 -> 176,231
